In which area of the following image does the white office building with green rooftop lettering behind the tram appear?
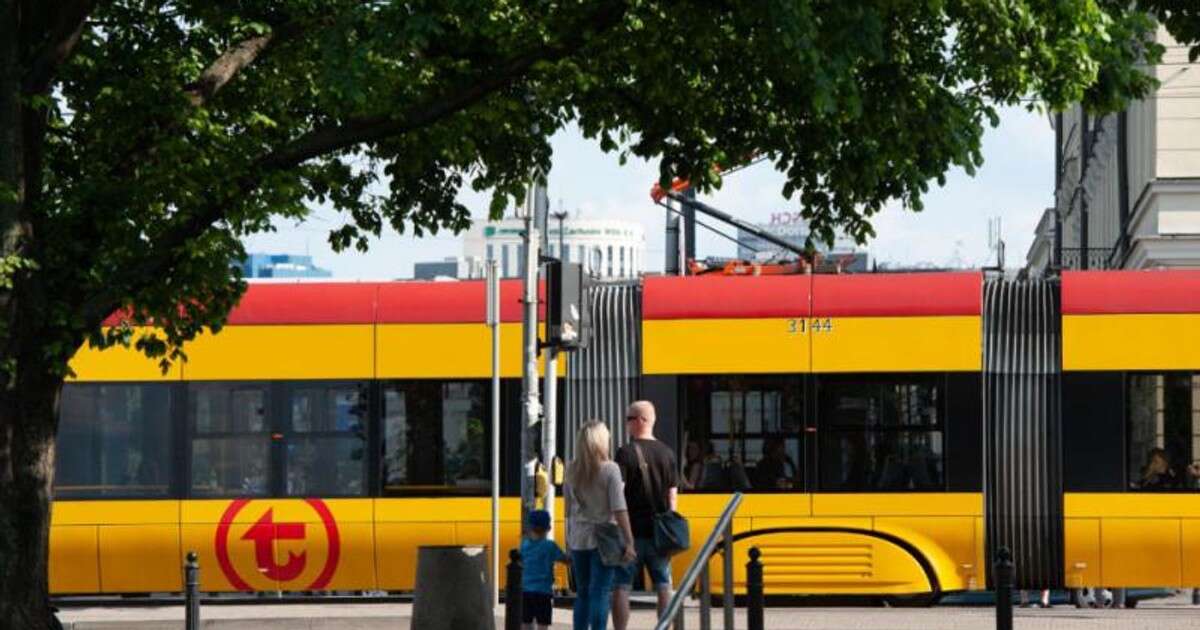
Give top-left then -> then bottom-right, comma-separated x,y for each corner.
463,218 -> 646,278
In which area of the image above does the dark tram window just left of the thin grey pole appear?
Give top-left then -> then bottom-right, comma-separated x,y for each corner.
383,380 -> 491,494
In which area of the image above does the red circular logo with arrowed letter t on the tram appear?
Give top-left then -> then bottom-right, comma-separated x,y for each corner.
214,499 -> 341,590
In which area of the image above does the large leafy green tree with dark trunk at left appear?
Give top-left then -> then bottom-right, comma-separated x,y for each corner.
0,0 -> 1184,629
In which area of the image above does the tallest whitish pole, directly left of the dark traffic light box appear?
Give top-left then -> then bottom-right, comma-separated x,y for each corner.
521,189 -> 541,533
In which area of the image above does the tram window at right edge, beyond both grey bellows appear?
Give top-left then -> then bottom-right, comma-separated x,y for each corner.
1128,372 -> 1200,492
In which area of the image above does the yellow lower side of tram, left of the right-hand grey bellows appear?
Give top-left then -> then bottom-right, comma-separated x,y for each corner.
50,494 -> 980,595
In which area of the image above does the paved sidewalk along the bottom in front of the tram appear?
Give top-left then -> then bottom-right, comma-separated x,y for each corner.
59,596 -> 1200,630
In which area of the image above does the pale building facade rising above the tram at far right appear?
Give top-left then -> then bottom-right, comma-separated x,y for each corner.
1026,28 -> 1200,271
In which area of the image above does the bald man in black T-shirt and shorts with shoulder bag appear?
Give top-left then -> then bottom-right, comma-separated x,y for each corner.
612,401 -> 679,630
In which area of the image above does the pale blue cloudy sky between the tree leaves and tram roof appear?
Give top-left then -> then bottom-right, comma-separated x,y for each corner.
246,108 -> 1054,280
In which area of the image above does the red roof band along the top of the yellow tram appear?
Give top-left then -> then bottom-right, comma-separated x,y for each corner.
106,270 -> 1200,325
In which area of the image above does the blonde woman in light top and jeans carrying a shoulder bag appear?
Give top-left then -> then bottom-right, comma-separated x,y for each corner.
563,420 -> 635,630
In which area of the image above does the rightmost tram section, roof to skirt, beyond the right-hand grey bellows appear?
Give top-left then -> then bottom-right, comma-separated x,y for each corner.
1062,271 -> 1200,588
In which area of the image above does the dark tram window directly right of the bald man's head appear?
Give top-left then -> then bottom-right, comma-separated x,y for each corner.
682,376 -> 804,492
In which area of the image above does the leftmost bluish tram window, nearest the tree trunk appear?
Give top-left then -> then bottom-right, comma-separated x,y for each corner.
54,384 -> 172,498
